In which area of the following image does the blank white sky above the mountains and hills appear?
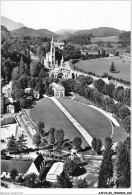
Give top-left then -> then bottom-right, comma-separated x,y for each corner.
1,0 -> 131,32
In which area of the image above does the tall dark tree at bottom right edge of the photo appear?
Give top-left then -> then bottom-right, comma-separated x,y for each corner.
115,138 -> 131,188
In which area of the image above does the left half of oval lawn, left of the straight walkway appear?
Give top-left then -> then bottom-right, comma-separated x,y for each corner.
30,98 -> 87,147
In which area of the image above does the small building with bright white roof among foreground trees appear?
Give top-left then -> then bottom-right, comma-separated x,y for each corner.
46,162 -> 64,182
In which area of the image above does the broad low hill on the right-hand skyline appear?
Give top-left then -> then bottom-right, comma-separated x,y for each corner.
74,27 -> 123,37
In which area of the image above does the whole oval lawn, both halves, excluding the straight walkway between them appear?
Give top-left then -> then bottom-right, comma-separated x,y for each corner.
30,98 -> 111,146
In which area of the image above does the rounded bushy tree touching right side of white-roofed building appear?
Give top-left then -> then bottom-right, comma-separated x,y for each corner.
64,158 -> 77,175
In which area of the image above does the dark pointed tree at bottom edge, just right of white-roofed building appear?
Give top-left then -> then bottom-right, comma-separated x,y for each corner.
56,172 -> 72,188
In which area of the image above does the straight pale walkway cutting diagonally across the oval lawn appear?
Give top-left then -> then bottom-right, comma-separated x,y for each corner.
49,97 -> 93,146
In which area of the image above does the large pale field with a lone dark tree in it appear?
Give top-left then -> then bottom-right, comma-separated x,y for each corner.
74,57 -> 130,81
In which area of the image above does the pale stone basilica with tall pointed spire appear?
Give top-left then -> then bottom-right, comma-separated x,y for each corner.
44,37 -> 71,79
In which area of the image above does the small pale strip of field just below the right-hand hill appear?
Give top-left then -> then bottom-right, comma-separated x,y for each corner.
91,35 -> 119,43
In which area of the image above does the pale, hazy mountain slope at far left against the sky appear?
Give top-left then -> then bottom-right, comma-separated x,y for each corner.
1,16 -> 24,31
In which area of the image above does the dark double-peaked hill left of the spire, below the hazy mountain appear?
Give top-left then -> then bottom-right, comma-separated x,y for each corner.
11,27 -> 54,37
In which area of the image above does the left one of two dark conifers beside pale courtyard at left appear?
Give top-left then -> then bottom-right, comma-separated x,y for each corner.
7,135 -> 18,152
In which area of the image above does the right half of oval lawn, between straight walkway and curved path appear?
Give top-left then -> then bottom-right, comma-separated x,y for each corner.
58,99 -> 112,141
